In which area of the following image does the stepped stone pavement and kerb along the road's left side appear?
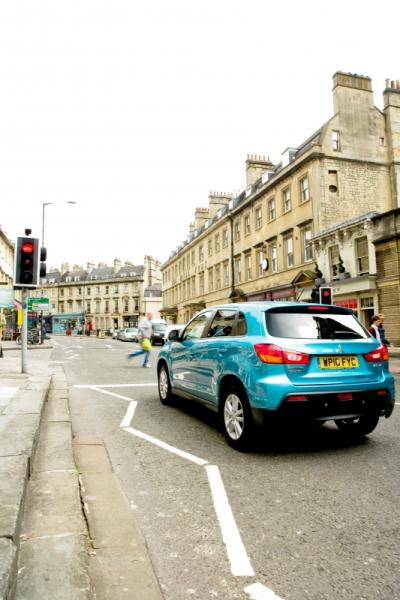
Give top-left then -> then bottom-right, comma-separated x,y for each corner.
0,340 -> 162,600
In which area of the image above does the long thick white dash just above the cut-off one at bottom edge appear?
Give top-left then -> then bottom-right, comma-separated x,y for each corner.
205,465 -> 254,577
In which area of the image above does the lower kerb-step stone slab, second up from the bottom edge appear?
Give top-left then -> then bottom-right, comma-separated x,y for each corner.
23,471 -> 86,539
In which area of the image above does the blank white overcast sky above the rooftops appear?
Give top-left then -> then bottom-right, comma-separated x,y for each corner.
0,0 -> 400,267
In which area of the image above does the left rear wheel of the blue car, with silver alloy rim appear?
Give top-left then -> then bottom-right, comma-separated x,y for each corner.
221,385 -> 255,452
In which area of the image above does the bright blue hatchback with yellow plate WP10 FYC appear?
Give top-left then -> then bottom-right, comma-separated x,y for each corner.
157,302 -> 395,450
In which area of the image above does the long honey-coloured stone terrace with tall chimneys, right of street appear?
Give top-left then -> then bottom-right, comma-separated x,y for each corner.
161,72 -> 400,322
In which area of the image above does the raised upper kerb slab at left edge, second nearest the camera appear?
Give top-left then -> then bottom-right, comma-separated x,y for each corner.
0,454 -> 28,540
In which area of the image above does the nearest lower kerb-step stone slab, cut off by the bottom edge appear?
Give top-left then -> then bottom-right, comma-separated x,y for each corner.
14,535 -> 93,600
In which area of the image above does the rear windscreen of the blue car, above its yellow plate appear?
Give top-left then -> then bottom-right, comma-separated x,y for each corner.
266,311 -> 370,340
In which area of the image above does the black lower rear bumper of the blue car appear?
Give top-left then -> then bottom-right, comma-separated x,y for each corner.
252,388 -> 394,424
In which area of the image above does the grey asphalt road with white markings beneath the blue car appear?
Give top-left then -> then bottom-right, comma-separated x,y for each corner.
53,337 -> 400,600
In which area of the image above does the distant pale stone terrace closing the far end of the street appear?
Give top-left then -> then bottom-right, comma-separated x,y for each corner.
38,256 -> 161,333
